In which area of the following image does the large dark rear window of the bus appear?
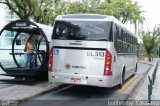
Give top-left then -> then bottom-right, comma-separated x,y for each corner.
52,21 -> 111,41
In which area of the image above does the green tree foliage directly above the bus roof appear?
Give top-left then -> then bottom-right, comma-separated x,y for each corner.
68,0 -> 142,23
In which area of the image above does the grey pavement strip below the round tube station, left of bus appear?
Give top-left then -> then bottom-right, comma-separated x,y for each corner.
0,68 -> 62,101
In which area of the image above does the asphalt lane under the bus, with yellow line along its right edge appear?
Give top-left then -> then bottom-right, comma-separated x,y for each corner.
19,63 -> 151,106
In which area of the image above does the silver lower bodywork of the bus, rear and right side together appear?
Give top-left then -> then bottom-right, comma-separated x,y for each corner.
49,41 -> 137,87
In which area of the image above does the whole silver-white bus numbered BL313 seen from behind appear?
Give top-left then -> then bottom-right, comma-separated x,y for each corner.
48,14 -> 137,88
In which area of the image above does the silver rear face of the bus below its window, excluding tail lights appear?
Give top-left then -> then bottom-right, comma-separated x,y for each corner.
49,41 -> 114,87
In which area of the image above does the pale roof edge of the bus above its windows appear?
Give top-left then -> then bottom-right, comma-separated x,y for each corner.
56,14 -> 136,37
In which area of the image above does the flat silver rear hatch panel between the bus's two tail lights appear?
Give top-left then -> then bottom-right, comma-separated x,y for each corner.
53,48 -> 105,76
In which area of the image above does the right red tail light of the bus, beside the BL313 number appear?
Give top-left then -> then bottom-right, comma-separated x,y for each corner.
104,49 -> 112,76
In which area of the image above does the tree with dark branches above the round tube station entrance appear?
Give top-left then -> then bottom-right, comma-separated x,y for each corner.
0,0 -> 61,24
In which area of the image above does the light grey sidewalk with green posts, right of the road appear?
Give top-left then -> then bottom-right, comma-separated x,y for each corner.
128,59 -> 160,101
